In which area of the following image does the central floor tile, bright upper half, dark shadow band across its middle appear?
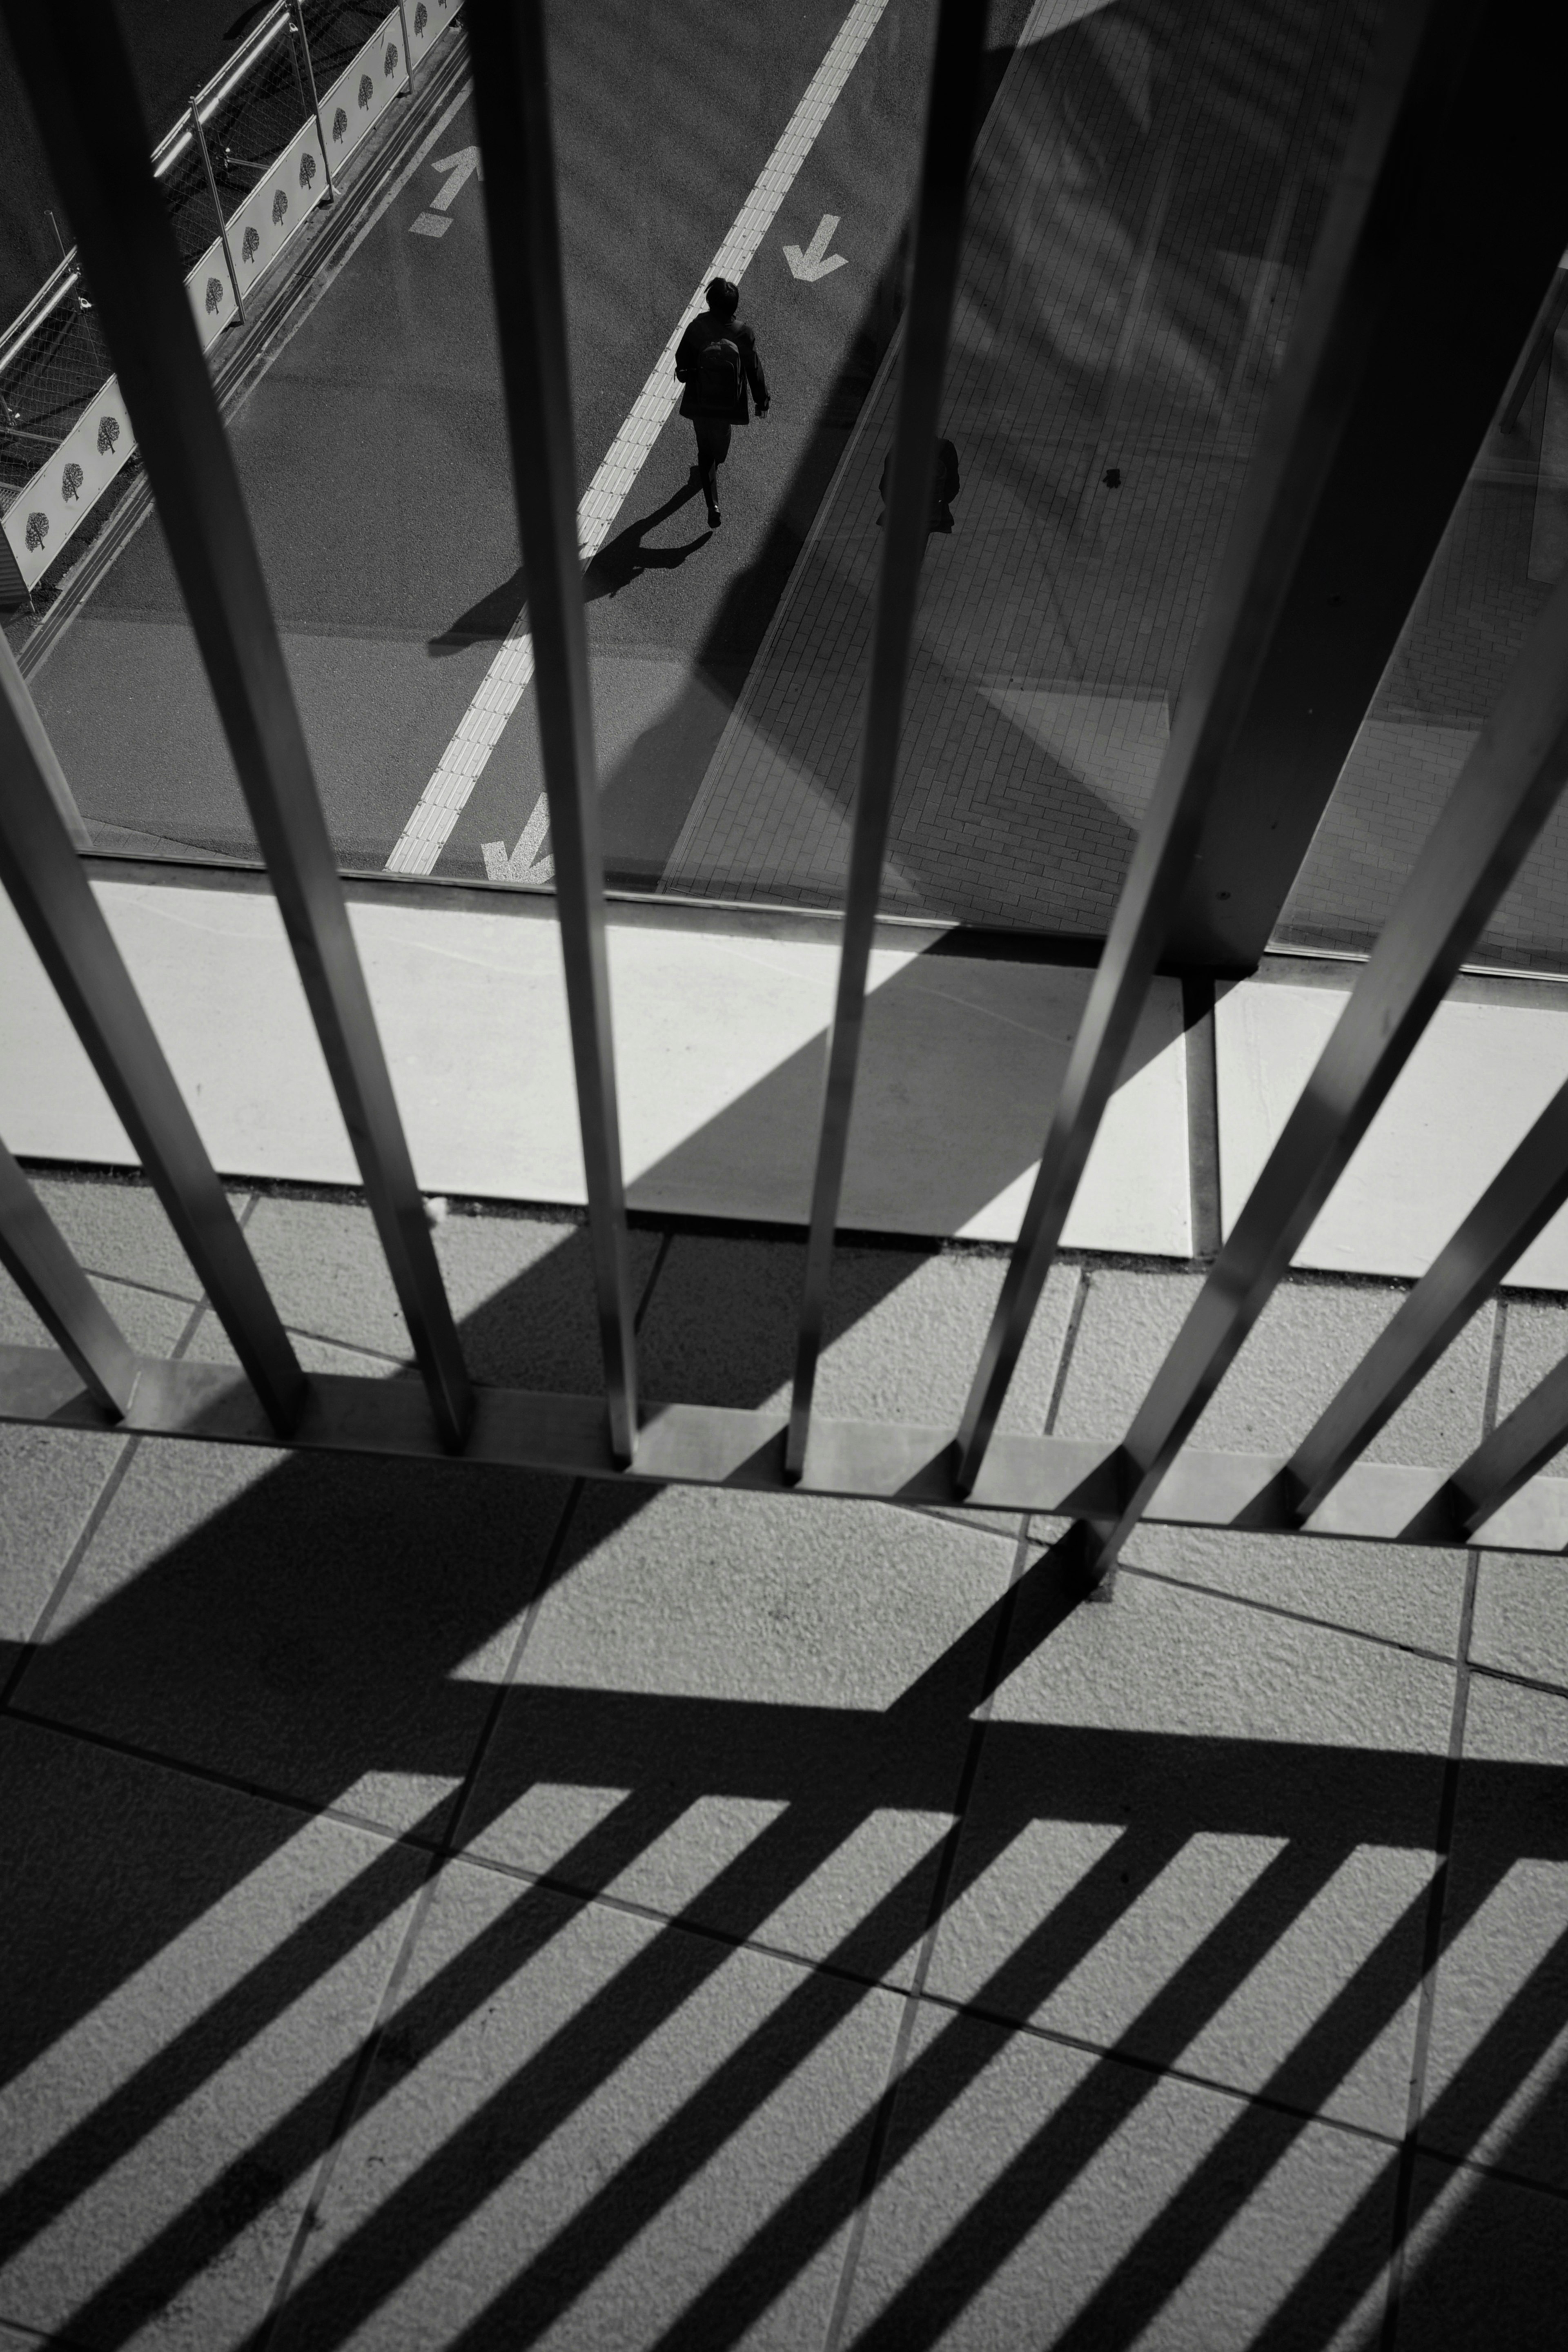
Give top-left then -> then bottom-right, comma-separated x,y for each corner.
468,1489 -> 1011,1980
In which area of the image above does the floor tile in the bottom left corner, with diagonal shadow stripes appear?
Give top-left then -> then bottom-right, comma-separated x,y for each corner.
0,1724 -> 423,2352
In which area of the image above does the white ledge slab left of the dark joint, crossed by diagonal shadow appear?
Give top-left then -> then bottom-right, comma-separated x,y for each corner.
0,880 -> 1192,1258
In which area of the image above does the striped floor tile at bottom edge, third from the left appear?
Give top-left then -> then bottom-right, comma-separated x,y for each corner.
844,2009 -> 1392,2352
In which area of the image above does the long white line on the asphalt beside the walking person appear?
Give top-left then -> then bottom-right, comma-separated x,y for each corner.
385,0 -> 889,882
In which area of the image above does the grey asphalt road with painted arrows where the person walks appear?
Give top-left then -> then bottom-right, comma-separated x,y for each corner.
33,0 -> 1025,887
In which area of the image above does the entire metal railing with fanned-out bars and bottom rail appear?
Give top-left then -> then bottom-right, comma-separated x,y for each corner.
0,0 -> 1568,1583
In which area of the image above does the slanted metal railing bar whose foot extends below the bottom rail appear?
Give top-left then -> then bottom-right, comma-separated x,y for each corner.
1098,555 -> 1568,1559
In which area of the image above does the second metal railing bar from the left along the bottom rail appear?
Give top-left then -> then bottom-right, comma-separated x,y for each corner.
0,637 -> 305,1432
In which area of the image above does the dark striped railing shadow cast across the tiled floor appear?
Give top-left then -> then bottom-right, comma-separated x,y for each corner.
0,1218 -> 1568,2352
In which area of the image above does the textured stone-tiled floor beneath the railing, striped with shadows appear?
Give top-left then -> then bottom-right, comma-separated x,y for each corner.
0,1181 -> 1568,2352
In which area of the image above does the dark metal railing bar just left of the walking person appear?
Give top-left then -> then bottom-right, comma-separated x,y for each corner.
468,0 -> 637,1465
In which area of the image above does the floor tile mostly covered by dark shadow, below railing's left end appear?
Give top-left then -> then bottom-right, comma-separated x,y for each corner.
19,1439 -> 566,1830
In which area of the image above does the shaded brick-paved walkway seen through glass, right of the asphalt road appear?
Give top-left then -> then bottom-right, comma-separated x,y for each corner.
663,0 -> 1568,964
